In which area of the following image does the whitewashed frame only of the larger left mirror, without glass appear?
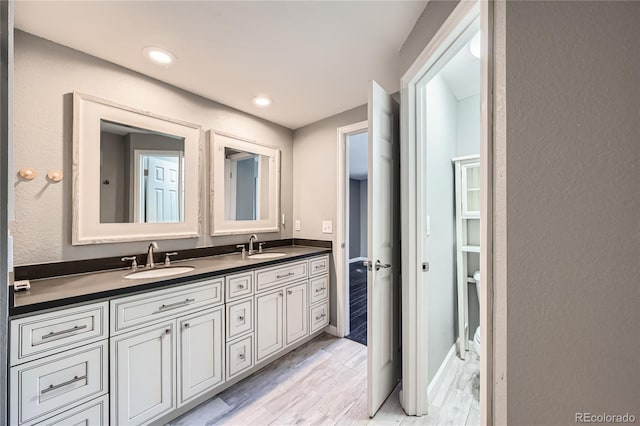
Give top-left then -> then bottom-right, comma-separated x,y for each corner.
71,92 -> 203,245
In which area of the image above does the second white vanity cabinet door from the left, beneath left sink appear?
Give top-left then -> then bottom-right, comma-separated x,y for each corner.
178,306 -> 224,405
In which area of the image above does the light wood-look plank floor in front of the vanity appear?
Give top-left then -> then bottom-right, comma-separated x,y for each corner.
171,334 -> 480,426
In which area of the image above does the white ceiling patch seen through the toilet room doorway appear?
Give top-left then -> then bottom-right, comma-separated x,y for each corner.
440,33 -> 480,100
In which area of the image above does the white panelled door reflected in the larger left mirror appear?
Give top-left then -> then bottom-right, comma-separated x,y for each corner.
146,156 -> 180,223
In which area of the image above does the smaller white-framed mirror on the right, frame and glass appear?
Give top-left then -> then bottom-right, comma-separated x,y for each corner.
209,130 -> 280,235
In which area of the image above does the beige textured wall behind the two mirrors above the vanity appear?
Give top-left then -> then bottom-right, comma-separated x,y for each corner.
11,31 -> 294,265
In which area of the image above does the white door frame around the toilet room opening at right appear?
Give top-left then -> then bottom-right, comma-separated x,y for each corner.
400,1 -> 493,424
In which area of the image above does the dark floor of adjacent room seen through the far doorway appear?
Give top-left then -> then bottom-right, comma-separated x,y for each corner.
346,262 -> 367,345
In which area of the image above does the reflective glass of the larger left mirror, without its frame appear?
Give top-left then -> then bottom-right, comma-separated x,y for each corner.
100,120 -> 184,223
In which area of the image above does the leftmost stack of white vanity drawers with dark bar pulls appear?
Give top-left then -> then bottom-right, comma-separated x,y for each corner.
9,302 -> 109,425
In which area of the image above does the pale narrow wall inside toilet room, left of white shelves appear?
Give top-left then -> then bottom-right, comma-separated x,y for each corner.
426,74 -> 457,381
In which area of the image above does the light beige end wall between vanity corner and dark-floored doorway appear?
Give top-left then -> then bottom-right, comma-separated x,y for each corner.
293,105 -> 367,325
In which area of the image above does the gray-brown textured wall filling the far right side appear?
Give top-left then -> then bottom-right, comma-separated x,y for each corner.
494,1 -> 640,425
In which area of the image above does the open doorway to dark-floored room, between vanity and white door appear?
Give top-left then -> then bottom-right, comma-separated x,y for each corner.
345,131 -> 369,346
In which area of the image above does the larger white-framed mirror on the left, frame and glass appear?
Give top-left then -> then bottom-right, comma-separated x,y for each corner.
72,92 -> 202,245
